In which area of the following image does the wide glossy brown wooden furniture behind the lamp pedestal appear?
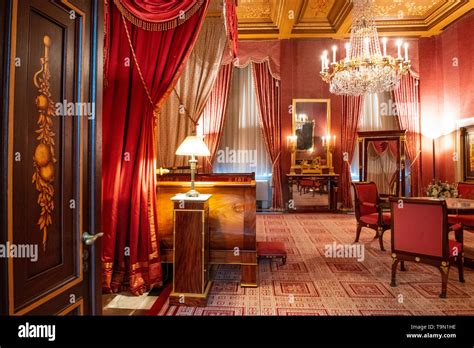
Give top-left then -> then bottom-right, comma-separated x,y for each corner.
157,174 -> 257,286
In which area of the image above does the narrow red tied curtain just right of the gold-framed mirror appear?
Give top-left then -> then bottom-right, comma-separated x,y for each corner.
340,96 -> 362,208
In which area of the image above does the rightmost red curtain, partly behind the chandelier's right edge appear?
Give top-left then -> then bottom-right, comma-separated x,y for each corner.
393,73 -> 421,196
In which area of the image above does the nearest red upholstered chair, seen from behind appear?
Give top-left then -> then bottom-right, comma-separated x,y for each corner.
390,198 -> 464,298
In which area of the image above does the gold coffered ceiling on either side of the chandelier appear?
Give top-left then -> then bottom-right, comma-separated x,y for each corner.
237,0 -> 474,39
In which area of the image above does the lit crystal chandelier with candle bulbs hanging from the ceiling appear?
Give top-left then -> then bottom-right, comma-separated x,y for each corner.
321,0 -> 410,95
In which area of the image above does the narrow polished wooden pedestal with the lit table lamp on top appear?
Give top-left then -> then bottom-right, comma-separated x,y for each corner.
170,194 -> 212,306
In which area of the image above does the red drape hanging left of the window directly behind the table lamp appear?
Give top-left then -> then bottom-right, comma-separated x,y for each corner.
199,64 -> 233,173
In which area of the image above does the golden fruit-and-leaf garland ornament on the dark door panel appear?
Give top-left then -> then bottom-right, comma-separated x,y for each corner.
32,35 -> 57,251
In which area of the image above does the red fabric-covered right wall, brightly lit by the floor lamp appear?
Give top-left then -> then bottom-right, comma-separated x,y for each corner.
419,13 -> 474,187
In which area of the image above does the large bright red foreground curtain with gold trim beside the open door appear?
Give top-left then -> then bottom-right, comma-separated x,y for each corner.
102,1 -> 208,294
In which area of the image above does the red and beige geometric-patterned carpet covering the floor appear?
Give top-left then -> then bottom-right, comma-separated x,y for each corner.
159,214 -> 474,316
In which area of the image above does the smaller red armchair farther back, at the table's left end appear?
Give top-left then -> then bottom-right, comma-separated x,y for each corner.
352,182 -> 390,251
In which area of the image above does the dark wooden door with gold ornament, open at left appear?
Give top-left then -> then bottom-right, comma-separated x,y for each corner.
0,0 -> 103,315
